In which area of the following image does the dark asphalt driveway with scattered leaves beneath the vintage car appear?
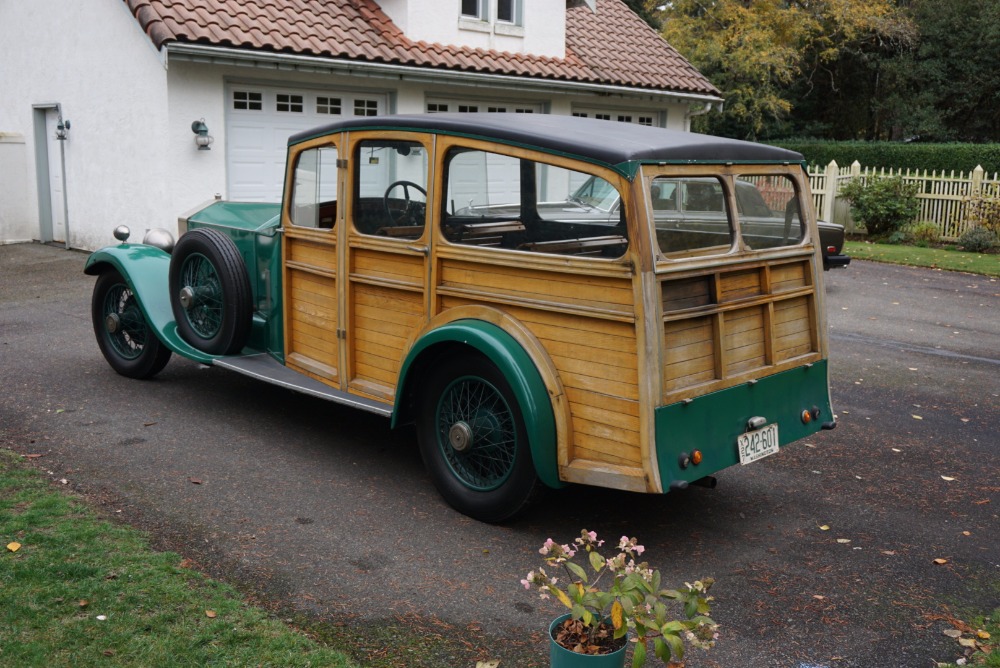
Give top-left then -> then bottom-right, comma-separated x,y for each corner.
0,244 -> 1000,668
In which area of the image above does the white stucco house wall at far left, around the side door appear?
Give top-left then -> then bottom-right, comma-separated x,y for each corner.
0,0 -> 169,248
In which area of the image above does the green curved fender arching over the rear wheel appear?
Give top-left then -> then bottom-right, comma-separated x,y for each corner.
392,319 -> 564,488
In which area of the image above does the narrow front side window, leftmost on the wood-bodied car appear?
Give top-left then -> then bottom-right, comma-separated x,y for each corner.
289,146 -> 337,229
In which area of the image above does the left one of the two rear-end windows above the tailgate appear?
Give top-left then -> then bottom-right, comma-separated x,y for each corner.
649,176 -> 735,257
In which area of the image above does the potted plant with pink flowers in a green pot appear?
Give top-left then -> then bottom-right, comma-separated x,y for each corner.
521,529 -> 717,668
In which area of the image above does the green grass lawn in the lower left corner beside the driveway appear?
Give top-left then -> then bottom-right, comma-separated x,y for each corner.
0,449 -> 354,668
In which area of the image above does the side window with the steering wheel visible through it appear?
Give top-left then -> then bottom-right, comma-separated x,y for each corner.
352,139 -> 427,240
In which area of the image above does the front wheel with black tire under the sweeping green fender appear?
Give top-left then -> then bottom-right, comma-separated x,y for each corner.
90,269 -> 170,379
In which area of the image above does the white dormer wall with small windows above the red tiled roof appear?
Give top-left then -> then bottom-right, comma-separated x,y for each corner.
376,0 -> 566,58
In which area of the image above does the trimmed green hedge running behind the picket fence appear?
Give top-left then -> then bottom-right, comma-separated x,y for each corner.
768,139 -> 1000,175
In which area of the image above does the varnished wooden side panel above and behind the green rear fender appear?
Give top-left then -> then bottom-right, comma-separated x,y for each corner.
436,253 -> 643,474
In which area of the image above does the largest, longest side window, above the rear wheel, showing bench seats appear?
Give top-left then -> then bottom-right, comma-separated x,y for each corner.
441,149 -> 628,258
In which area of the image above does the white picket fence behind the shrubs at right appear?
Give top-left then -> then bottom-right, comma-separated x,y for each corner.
809,160 -> 1000,241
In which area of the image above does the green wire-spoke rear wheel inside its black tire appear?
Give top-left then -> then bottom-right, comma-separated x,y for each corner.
437,377 -> 517,491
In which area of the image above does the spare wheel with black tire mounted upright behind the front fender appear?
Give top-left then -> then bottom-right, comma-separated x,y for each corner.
170,228 -> 253,355
